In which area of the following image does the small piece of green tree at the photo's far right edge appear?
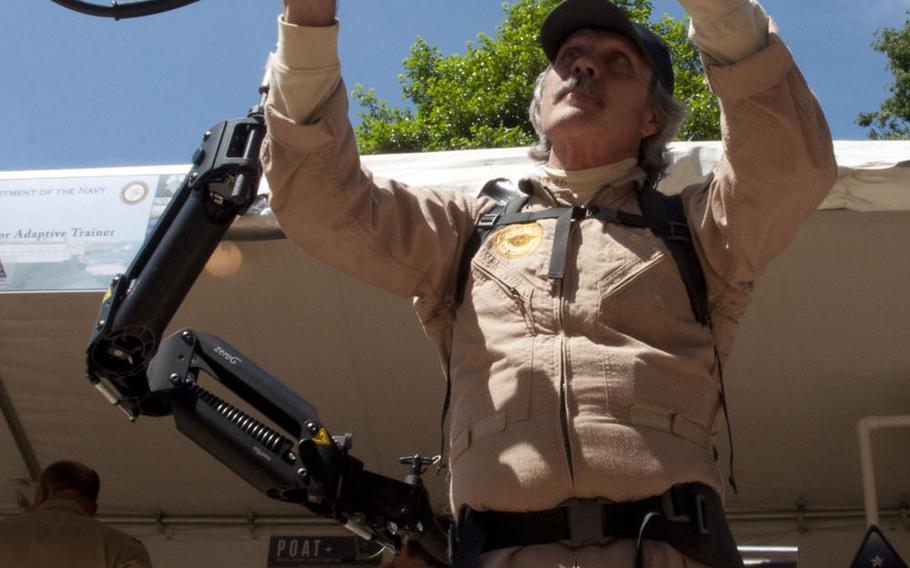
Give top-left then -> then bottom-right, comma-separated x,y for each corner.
856,12 -> 910,140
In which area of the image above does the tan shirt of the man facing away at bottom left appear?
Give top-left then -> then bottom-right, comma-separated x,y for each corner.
0,499 -> 152,568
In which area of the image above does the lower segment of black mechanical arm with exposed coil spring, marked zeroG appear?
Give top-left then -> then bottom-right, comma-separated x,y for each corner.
148,330 -> 441,550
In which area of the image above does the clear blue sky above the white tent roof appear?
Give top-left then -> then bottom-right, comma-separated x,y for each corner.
0,0 -> 910,171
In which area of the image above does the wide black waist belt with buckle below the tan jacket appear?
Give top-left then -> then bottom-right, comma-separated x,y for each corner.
454,483 -> 743,568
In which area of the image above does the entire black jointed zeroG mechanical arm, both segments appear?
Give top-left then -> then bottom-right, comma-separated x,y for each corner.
86,60 -> 447,562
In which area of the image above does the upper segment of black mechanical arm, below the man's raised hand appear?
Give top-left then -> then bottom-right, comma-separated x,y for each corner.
86,117 -> 265,418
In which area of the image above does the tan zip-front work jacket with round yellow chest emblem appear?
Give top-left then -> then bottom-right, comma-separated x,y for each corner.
262,27 -> 836,511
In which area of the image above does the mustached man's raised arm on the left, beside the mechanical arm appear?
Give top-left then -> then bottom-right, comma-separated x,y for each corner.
261,0 -> 479,303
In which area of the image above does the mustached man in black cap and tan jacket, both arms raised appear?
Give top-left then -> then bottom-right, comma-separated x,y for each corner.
262,0 -> 836,567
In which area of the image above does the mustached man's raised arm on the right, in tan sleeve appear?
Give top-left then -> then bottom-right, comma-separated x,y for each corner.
679,0 -> 837,355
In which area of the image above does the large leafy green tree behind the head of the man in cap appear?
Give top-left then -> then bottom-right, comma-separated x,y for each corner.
352,0 -> 720,154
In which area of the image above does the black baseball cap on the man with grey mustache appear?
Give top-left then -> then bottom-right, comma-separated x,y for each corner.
540,0 -> 673,94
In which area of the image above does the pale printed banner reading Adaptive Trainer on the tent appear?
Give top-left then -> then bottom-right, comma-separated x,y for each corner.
0,174 -> 183,292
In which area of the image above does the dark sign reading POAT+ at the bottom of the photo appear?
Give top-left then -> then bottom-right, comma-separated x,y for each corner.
268,536 -> 382,568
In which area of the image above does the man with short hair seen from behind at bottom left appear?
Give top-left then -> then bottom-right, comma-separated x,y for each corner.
0,461 -> 152,568
